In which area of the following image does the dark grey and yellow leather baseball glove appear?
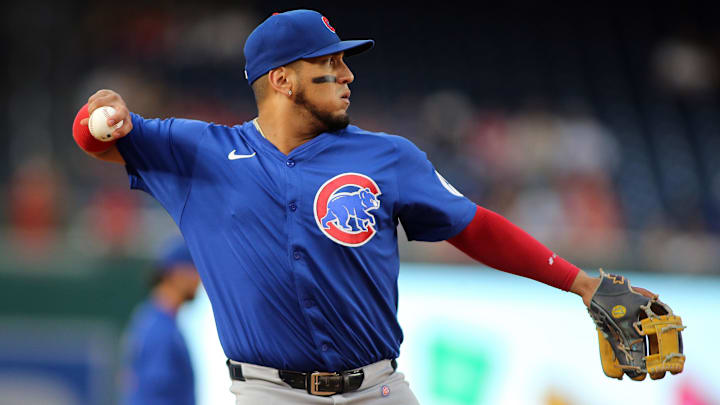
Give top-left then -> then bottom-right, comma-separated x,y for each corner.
588,269 -> 685,381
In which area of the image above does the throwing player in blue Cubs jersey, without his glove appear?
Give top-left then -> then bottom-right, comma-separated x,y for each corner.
75,10 -> 660,405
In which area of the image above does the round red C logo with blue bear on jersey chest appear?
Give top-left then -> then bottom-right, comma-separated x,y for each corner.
313,173 -> 381,247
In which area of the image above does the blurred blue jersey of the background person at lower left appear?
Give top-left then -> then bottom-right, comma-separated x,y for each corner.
122,299 -> 195,405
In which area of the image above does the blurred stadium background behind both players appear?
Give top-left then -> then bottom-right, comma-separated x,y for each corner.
0,0 -> 720,404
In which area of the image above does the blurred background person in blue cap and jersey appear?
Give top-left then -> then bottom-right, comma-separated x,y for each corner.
121,238 -> 200,405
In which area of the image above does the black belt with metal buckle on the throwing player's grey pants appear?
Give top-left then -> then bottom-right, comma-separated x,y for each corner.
227,359 -> 397,396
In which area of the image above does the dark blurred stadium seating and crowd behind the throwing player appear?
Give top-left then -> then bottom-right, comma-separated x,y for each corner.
5,2 -> 720,273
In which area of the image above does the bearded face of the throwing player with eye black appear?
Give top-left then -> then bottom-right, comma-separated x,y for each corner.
294,52 -> 355,132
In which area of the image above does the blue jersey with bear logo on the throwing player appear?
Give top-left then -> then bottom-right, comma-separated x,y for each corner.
117,114 -> 476,371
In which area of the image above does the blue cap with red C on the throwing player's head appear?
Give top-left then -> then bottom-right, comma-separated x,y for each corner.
245,10 -> 375,84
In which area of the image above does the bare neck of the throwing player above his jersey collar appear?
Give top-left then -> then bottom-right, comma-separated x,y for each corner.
255,109 -> 318,155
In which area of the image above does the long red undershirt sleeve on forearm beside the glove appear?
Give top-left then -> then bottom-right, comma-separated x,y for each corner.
448,206 -> 580,291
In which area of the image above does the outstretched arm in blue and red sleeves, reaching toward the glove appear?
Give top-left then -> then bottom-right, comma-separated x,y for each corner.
389,137 -> 656,305
